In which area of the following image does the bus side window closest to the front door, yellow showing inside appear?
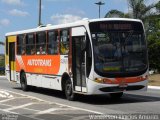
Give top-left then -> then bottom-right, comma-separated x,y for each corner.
60,30 -> 69,55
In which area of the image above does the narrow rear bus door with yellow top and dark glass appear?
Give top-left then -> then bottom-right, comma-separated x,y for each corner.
8,36 -> 16,81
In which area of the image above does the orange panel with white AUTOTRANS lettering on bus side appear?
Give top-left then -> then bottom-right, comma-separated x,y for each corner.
16,55 -> 60,74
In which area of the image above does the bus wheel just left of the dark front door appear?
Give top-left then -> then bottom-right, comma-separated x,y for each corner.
64,79 -> 75,101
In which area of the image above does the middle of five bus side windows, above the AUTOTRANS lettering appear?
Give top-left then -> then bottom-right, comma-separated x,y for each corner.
36,32 -> 46,54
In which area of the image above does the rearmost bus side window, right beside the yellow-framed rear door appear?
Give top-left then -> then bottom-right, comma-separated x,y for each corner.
17,35 -> 26,55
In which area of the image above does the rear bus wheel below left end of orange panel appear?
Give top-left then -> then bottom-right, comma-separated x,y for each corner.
20,72 -> 28,91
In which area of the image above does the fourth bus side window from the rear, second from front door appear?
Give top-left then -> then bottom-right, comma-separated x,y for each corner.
47,31 -> 58,55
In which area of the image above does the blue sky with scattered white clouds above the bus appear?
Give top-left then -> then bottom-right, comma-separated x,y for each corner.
0,0 -> 159,53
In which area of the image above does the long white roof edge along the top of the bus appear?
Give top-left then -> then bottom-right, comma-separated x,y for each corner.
5,18 -> 142,36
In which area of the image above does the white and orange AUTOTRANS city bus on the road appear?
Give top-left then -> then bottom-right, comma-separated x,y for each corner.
5,18 -> 149,100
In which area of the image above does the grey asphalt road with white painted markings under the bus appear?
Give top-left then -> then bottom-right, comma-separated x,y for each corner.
0,77 -> 160,120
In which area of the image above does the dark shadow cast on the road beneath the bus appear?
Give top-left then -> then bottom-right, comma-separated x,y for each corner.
14,87 -> 160,105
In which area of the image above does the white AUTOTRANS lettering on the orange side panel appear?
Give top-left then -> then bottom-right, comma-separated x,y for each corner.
27,59 -> 52,67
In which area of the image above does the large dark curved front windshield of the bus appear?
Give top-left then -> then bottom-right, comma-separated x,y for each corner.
90,22 -> 147,76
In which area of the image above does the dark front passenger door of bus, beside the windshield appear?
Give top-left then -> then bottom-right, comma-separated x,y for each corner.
72,36 -> 87,92
